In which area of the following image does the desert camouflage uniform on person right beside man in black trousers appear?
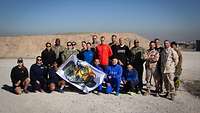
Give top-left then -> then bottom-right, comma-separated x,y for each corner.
145,49 -> 160,93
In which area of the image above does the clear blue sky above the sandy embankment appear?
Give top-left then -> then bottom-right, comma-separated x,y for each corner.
0,0 -> 200,40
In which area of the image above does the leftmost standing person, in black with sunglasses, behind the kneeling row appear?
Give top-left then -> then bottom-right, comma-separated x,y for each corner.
41,42 -> 56,68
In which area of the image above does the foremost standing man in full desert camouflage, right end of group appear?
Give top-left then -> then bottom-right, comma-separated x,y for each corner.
161,40 -> 178,100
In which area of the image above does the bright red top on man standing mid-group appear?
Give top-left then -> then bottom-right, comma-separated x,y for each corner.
96,44 -> 112,65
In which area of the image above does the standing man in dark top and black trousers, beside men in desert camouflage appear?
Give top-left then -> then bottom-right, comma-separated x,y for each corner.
130,40 -> 146,93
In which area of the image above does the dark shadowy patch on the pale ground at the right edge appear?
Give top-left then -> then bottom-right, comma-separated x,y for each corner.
183,80 -> 200,97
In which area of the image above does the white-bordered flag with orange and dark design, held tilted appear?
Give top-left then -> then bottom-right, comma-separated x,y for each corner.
56,54 -> 105,93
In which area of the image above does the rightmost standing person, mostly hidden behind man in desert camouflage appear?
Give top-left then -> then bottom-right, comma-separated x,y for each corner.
171,42 -> 183,91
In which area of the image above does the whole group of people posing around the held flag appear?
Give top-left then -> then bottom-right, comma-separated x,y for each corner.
11,35 -> 182,100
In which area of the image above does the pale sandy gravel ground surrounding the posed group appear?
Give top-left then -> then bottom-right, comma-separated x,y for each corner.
0,52 -> 200,113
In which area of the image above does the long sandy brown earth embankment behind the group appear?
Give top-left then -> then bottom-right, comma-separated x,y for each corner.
0,33 -> 149,58
